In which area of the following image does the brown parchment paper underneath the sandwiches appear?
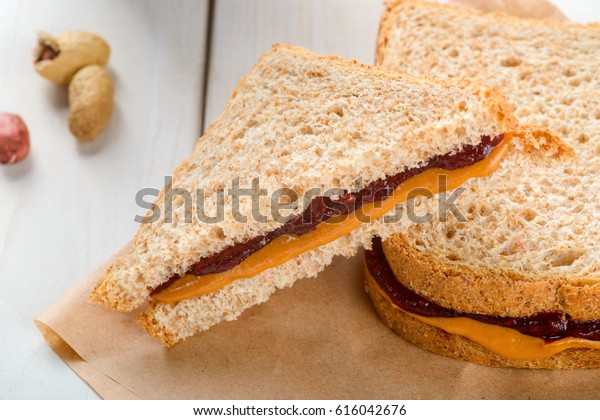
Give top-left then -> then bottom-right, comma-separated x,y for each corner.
35,0 -> 600,399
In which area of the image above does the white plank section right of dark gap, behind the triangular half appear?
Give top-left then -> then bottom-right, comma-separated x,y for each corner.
205,0 -> 384,128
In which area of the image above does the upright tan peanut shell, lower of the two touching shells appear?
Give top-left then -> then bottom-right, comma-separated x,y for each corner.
69,65 -> 114,141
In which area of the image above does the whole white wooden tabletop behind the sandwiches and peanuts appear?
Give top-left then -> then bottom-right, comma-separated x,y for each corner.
0,0 -> 600,399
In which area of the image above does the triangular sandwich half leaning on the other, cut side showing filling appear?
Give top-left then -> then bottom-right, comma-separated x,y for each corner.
90,45 -> 533,346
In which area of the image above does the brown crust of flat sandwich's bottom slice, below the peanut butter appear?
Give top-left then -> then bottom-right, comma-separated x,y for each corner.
365,268 -> 600,369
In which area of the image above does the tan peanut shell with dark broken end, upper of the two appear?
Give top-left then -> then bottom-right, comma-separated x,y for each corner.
35,31 -> 110,85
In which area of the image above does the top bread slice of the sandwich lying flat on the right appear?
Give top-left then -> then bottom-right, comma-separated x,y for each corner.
376,0 -> 600,320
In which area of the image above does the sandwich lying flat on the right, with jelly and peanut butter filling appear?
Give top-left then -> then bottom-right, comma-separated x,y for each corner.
366,0 -> 600,369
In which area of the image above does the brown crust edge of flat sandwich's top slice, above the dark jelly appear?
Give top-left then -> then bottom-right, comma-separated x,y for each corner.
383,234 -> 600,321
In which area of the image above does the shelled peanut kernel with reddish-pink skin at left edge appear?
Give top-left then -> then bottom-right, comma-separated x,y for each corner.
0,113 -> 29,165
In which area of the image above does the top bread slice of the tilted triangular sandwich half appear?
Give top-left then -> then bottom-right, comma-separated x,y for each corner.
91,45 -> 516,312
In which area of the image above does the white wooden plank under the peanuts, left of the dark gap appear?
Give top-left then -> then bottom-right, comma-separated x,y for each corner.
0,0 -> 208,398
